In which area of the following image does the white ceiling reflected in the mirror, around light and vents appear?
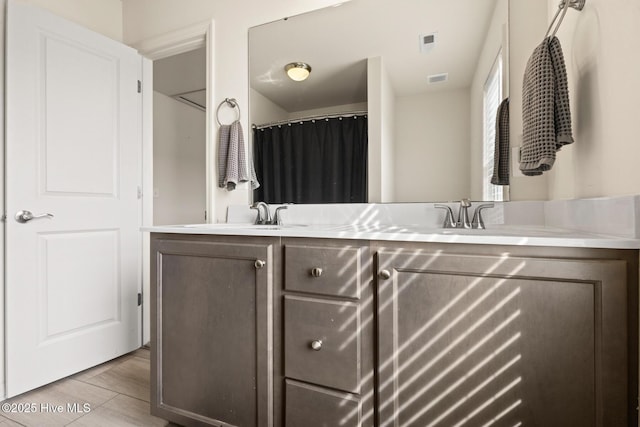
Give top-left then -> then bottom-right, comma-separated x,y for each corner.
249,0 -> 497,112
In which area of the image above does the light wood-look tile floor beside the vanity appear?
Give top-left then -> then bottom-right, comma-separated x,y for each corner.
0,348 -> 174,427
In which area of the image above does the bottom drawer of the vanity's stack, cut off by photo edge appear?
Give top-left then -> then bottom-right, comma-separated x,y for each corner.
285,380 -> 362,427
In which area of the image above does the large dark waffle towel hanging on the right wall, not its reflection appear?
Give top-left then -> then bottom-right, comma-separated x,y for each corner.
520,37 -> 573,176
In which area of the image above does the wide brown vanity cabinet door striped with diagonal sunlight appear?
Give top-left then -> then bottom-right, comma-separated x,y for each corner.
378,251 -> 627,427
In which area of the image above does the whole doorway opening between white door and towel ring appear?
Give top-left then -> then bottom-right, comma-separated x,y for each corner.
153,47 -> 207,225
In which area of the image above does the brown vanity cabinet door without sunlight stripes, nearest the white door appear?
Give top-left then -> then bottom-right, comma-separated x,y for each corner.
151,238 -> 273,427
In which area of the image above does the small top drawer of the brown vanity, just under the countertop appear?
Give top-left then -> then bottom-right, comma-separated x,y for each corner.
284,245 -> 363,298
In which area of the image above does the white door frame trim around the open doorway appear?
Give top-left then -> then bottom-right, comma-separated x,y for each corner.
131,20 -> 216,344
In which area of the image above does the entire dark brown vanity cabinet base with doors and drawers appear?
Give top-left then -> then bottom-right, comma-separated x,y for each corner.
151,233 -> 638,427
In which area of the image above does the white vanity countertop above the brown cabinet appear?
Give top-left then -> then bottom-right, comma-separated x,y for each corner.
142,223 -> 640,249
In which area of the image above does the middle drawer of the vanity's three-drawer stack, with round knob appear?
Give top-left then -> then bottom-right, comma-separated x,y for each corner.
284,295 -> 360,393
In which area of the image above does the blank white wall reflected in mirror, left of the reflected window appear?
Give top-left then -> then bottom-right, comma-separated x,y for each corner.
395,89 -> 470,202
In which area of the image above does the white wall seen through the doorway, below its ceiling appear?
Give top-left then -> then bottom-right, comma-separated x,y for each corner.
153,92 -> 206,225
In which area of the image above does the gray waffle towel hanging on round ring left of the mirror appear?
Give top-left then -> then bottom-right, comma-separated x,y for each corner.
218,120 -> 260,191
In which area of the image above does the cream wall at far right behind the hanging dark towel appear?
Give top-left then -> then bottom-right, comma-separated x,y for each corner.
547,0 -> 640,199
